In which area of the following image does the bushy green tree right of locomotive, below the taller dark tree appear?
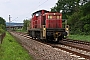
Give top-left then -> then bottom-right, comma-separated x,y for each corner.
68,2 -> 90,34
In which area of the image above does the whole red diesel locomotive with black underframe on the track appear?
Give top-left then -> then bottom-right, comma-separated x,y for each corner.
28,10 -> 66,42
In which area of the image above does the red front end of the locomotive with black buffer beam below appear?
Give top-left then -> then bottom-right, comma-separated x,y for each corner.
46,13 -> 66,42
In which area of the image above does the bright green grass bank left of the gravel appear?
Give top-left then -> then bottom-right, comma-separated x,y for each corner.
0,32 -> 33,60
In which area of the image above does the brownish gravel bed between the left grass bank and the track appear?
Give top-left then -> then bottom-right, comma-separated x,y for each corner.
11,32 -> 84,60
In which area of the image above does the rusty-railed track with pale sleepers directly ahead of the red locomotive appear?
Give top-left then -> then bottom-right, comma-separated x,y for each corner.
51,45 -> 90,59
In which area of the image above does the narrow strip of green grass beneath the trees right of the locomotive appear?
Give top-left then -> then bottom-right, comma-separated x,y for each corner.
68,35 -> 90,42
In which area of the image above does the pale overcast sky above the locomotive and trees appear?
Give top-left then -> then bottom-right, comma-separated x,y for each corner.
0,0 -> 58,23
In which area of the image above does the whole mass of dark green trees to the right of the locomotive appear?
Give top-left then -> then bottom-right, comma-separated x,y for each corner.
51,0 -> 90,35
